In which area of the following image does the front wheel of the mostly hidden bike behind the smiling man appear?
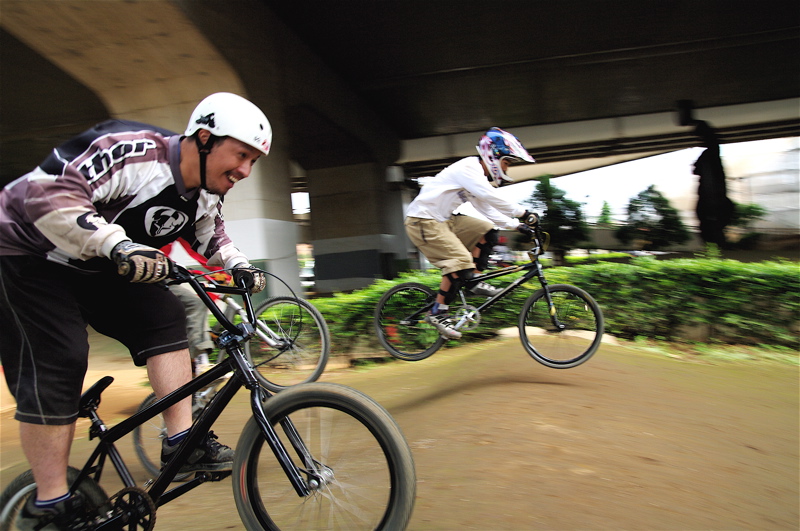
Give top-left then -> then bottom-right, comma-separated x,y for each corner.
244,297 -> 331,393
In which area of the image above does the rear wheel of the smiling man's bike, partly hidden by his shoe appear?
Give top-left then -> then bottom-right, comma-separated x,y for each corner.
0,467 -> 110,531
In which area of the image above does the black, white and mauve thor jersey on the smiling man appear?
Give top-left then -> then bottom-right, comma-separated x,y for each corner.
0,120 -> 247,270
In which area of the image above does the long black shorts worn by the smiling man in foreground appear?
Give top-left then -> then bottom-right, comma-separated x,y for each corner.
0,256 -> 188,424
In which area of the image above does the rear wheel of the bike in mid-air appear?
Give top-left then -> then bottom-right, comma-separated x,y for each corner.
374,282 -> 446,361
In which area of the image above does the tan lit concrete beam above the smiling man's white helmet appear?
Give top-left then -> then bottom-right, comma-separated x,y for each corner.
0,0 -> 244,131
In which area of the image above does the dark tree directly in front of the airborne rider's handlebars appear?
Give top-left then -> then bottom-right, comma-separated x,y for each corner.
528,175 -> 589,265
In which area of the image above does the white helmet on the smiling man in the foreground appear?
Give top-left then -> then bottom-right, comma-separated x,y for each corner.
184,92 -> 272,155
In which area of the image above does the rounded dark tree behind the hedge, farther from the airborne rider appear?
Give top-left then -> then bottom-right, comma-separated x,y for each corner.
615,185 -> 689,250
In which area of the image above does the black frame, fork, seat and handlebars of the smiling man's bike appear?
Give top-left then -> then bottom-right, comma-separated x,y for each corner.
70,266 -> 318,529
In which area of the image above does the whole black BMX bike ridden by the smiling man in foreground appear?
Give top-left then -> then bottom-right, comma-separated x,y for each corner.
0,266 -> 416,531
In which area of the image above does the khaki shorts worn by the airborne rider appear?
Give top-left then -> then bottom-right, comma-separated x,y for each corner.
405,215 -> 494,275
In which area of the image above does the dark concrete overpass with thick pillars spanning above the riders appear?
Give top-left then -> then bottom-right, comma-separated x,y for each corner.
0,0 -> 800,291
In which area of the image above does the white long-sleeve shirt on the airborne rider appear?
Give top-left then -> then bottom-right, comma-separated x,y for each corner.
406,157 -> 526,229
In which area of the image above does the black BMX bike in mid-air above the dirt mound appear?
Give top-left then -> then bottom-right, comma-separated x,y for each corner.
374,223 -> 604,369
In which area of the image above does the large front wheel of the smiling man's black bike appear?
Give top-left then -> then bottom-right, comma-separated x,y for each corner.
232,383 -> 416,531
